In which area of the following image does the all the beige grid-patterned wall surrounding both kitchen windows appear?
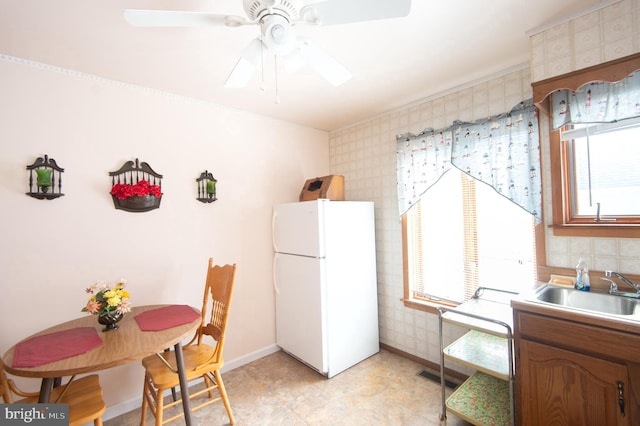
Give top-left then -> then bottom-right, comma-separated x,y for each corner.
329,0 -> 640,363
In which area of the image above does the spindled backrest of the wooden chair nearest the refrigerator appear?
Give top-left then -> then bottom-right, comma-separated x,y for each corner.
197,258 -> 236,359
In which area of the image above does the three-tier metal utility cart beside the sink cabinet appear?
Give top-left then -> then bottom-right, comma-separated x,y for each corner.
438,287 -> 516,426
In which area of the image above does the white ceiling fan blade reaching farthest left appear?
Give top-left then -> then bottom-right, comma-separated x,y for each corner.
123,9 -> 246,27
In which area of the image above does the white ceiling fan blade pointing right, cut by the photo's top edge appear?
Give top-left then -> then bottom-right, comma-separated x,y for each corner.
308,0 -> 411,25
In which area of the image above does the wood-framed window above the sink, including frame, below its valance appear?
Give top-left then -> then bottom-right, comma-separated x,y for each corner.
549,116 -> 640,238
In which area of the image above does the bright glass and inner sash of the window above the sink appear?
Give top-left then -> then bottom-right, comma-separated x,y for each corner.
561,119 -> 640,224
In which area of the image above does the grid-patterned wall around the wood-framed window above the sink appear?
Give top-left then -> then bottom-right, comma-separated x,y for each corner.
530,0 -> 640,279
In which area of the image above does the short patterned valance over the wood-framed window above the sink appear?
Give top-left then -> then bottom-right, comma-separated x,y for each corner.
551,71 -> 640,129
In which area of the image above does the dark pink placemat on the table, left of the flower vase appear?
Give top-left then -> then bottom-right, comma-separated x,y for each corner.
11,327 -> 102,367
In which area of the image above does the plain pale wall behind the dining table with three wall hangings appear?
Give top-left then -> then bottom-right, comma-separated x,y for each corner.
0,56 -> 329,418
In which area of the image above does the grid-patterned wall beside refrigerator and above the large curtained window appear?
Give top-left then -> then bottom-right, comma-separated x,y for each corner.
329,66 -> 531,362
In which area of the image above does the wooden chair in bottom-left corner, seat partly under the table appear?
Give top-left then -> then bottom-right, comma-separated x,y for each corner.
0,359 -> 107,426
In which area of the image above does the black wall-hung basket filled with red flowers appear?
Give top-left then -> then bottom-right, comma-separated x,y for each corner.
109,158 -> 162,212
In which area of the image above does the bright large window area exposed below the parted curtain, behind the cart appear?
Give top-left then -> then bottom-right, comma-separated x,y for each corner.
403,168 -> 536,304
